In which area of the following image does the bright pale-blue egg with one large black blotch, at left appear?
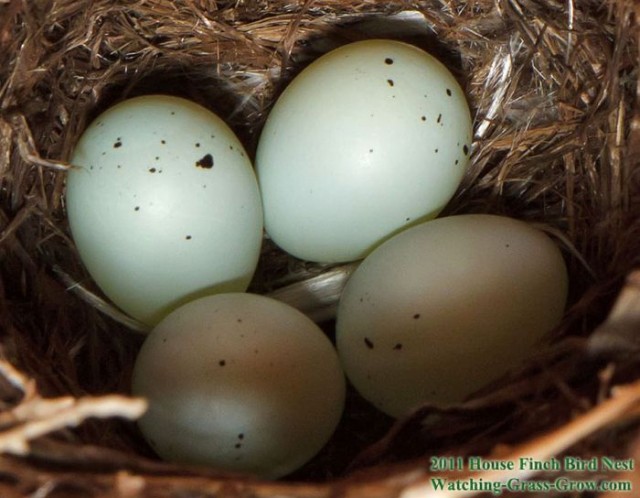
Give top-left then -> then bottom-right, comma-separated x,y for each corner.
66,95 -> 263,325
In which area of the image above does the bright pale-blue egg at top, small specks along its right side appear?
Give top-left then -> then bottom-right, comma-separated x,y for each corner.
256,40 -> 472,263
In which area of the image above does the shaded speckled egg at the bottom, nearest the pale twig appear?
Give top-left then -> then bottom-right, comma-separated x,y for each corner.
132,293 -> 345,478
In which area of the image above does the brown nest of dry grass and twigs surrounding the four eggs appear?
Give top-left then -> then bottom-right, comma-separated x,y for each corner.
0,0 -> 640,497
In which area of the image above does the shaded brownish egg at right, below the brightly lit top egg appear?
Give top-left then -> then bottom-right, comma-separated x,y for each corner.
336,214 -> 568,417
